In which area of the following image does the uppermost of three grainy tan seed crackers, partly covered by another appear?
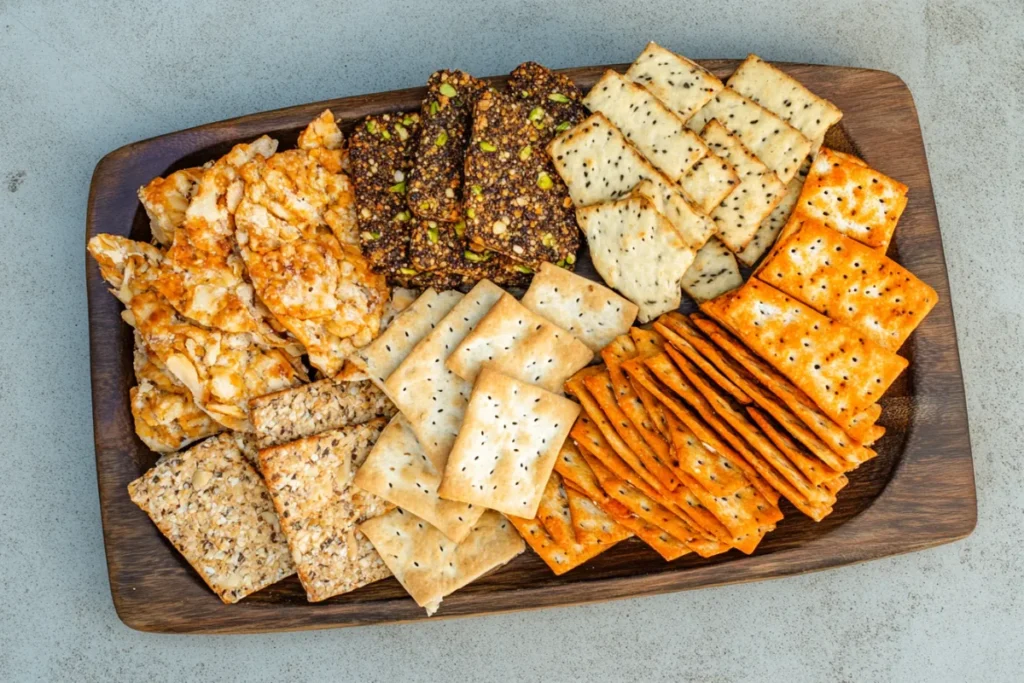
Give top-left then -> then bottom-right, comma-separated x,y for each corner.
249,379 -> 395,449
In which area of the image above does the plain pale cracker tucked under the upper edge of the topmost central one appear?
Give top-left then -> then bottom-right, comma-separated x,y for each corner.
445,292 -> 594,391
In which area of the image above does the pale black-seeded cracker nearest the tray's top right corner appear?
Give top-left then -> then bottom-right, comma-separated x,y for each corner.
726,54 -> 843,140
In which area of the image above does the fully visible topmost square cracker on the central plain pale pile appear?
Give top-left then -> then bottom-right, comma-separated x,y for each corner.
438,367 -> 580,518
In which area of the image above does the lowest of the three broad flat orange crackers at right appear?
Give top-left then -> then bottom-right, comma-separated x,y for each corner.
700,280 -> 907,421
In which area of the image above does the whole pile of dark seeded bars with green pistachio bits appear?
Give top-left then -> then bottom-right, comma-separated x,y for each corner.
350,62 -> 584,290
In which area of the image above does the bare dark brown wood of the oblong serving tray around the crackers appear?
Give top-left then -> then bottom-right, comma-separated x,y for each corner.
86,60 -> 977,633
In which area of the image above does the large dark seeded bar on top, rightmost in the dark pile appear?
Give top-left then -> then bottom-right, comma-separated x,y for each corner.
466,91 -> 580,269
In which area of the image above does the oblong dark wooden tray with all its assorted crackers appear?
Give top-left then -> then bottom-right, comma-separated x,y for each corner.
87,46 -> 976,633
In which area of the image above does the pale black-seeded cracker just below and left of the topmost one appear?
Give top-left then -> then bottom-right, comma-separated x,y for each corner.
583,70 -> 708,182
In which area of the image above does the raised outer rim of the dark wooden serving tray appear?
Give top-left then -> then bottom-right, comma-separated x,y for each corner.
85,59 -> 977,633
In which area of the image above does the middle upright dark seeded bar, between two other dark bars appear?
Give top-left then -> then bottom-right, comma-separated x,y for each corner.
409,71 -> 486,222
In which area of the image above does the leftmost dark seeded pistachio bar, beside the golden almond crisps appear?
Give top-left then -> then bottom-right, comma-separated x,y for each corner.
348,114 -> 420,282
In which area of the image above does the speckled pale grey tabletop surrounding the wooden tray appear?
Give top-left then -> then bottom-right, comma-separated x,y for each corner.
0,0 -> 1024,683
